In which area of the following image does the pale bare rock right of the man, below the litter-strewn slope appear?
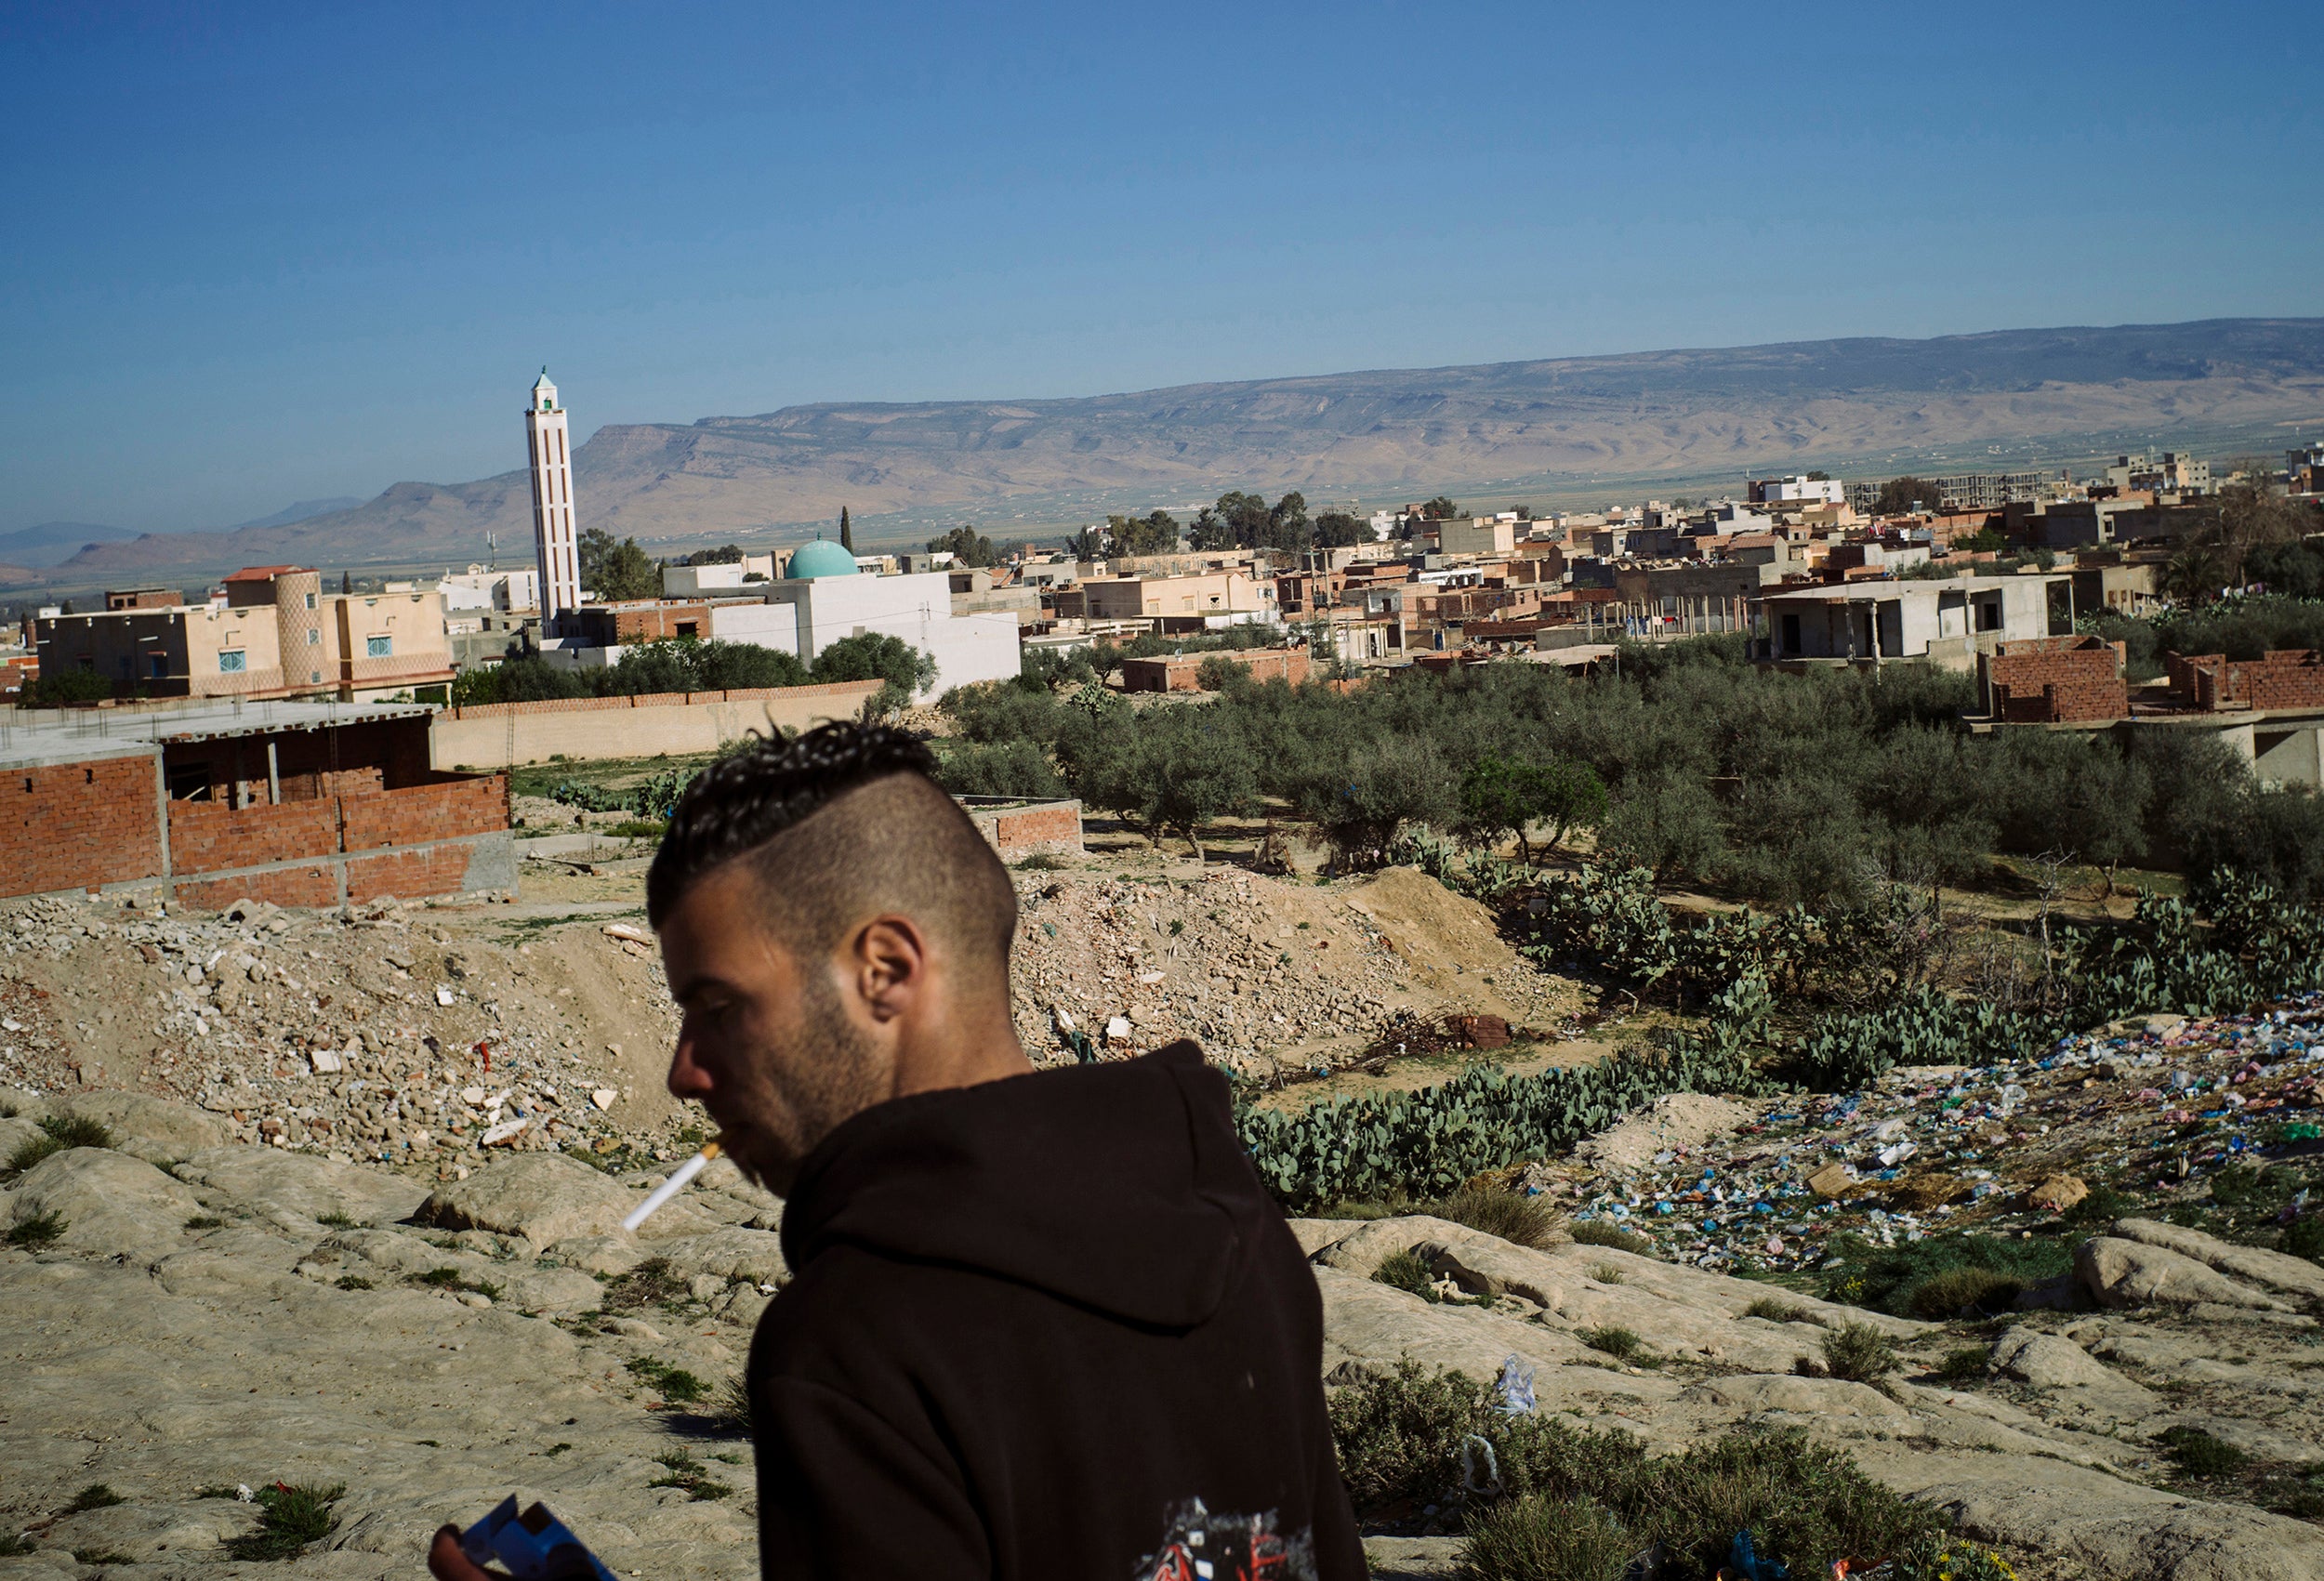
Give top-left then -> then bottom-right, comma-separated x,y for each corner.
1297,1219 -> 2324,1581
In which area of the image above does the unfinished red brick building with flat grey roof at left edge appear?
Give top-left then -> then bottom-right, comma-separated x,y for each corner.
0,702 -> 516,907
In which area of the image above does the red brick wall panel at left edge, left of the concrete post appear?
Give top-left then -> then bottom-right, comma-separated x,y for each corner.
0,756 -> 161,895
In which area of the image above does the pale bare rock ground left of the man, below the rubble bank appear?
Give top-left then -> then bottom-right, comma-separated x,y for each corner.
0,1100 -> 781,1576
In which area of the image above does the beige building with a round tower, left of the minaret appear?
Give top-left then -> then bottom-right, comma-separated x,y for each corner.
35,565 -> 451,700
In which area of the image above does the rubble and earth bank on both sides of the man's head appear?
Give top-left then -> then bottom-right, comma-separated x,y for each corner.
0,867 -> 1578,1172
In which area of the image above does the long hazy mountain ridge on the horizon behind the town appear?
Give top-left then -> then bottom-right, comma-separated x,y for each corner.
32,319 -> 2324,581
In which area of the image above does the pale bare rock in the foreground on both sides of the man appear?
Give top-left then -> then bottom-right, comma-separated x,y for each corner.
13,1093 -> 2324,1581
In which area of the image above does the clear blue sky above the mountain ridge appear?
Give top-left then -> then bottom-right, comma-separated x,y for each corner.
0,0 -> 2324,530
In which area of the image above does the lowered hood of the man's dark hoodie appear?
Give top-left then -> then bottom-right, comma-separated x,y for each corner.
784,1042 -> 1274,1330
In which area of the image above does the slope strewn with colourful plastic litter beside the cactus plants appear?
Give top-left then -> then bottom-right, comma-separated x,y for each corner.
1527,995 -> 2324,1271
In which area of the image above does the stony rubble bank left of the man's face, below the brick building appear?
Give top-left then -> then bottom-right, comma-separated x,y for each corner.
0,898 -> 672,1167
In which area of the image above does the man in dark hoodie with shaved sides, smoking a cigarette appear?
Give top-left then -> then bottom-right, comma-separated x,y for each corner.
430,725 -> 1365,1581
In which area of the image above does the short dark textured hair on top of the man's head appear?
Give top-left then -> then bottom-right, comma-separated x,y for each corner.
646,723 -> 937,928
